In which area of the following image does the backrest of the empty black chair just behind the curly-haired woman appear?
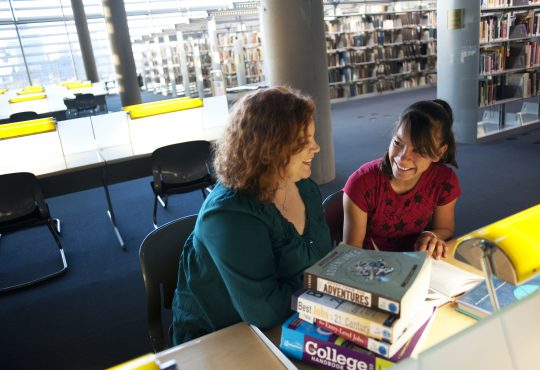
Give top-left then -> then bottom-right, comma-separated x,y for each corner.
152,140 -> 212,188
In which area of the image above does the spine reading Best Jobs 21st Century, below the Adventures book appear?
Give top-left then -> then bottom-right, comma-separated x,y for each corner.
291,295 -> 394,343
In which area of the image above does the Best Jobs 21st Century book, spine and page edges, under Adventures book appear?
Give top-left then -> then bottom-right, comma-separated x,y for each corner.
291,289 -> 433,344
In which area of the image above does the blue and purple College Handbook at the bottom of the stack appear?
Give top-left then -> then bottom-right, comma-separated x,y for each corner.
279,314 -> 394,370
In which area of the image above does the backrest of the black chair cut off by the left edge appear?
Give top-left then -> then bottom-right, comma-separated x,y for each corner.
0,172 -> 50,223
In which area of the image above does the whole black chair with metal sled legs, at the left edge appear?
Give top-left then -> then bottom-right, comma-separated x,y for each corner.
0,172 -> 68,293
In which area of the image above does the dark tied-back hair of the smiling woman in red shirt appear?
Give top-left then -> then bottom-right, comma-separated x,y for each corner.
381,99 -> 458,178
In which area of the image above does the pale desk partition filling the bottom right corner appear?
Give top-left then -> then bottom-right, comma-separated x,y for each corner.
392,290 -> 540,370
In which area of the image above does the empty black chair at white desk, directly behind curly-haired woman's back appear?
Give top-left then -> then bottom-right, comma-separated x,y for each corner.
150,140 -> 215,228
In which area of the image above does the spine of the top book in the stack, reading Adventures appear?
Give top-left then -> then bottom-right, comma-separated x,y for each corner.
304,272 -> 400,315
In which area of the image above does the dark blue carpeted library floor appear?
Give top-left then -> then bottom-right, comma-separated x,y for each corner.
0,88 -> 540,370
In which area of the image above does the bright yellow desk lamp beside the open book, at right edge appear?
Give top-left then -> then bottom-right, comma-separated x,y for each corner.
454,204 -> 540,312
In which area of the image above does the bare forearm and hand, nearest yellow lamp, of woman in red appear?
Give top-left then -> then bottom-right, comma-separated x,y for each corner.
415,198 -> 457,259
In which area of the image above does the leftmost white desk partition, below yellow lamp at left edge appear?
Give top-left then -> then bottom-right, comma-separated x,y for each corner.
0,131 -> 66,175
